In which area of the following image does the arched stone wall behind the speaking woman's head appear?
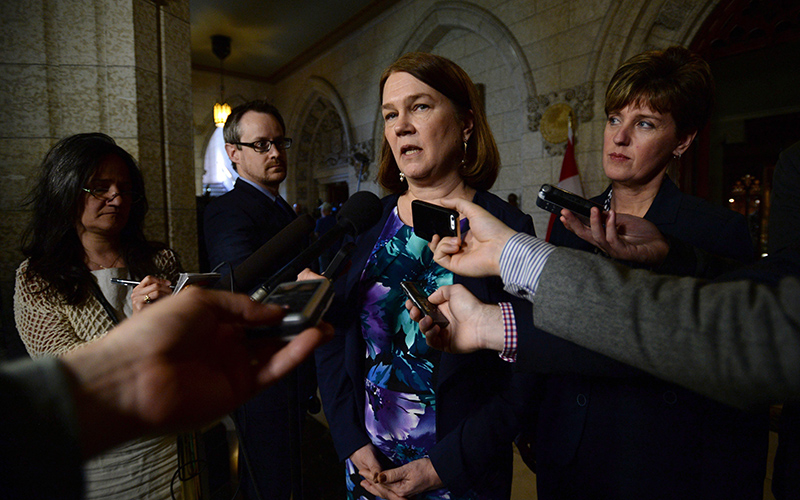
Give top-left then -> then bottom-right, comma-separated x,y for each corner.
252,0 -> 717,234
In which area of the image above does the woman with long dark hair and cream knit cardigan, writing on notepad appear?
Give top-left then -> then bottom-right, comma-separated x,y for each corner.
14,133 -> 180,499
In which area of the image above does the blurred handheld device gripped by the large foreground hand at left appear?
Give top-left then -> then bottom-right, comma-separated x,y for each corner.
248,278 -> 333,340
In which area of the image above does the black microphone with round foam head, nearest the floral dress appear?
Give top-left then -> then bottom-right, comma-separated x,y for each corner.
250,191 -> 383,302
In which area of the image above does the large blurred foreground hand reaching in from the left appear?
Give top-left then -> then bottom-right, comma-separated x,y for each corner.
61,287 -> 333,457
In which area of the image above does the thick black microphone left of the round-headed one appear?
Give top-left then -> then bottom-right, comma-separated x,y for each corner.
214,214 -> 314,293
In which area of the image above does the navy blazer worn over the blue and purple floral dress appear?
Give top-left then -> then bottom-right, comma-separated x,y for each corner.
315,191 -> 534,499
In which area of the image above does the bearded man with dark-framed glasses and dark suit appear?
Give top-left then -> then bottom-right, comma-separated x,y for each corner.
204,100 -> 316,500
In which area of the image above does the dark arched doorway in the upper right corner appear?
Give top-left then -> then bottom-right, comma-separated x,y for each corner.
680,0 -> 800,251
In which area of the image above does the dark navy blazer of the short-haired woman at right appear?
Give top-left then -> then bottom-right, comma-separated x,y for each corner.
520,178 -> 768,499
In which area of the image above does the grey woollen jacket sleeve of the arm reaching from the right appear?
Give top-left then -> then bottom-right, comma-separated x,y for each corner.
533,248 -> 800,406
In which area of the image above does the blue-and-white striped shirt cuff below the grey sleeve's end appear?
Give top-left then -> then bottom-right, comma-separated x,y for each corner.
500,233 -> 556,301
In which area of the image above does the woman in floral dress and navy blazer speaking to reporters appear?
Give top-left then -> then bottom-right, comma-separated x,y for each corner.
316,53 -> 533,499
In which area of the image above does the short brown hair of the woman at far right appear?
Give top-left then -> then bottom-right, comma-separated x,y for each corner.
605,46 -> 714,136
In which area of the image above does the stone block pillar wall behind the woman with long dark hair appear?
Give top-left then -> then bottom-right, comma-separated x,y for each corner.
0,0 -> 197,360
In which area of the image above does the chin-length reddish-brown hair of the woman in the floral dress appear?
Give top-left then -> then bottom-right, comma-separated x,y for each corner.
378,52 -> 500,193
